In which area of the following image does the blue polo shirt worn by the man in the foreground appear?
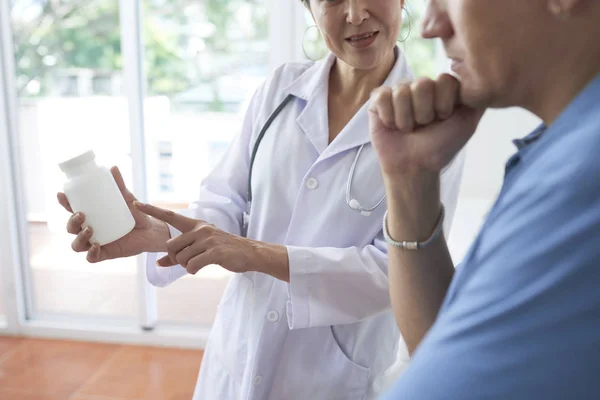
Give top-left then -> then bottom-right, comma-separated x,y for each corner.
383,76 -> 600,400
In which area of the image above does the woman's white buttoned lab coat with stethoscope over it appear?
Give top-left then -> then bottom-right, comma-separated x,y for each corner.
147,50 -> 463,400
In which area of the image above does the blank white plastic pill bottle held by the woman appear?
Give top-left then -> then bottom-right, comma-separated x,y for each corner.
59,150 -> 135,246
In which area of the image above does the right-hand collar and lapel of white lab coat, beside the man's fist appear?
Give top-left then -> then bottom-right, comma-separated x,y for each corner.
320,48 -> 413,160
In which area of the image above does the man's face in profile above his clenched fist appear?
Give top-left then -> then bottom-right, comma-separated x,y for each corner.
422,0 -> 554,107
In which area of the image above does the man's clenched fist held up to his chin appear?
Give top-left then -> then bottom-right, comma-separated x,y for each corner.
369,74 -> 484,178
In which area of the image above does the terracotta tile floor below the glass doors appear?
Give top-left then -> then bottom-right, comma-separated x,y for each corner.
0,336 -> 202,400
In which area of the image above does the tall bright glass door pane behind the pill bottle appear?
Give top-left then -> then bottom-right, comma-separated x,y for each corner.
12,0 -> 137,317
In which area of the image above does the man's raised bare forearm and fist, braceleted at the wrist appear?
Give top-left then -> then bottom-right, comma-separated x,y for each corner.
369,74 -> 484,353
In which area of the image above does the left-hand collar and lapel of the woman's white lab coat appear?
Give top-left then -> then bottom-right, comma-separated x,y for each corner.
286,54 -> 335,154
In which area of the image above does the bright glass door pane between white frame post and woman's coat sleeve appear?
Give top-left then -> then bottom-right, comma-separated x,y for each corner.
143,0 -> 269,326
